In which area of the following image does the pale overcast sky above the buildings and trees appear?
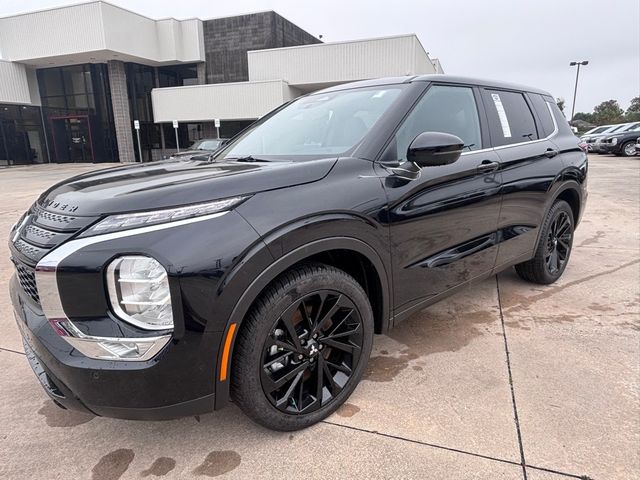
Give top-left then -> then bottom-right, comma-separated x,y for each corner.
0,0 -> 640,111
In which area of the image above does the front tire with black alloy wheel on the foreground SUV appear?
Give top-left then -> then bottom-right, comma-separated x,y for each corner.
231,263 -> 374,431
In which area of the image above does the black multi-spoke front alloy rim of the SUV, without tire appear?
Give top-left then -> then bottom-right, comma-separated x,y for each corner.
261,290 -> 363,415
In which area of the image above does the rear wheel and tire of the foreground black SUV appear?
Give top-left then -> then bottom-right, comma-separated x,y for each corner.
516,200 -> 575,285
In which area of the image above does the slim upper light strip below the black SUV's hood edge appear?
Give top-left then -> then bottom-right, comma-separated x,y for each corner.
82,196 -> 249,236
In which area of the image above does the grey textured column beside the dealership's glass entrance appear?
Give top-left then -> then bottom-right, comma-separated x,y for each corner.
107,60 -> 136,162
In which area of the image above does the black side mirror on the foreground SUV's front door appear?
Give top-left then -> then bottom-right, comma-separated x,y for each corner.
407,132 -> 464,167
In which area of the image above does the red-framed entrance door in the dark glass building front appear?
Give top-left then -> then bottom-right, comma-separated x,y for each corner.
50,115 -> 94,163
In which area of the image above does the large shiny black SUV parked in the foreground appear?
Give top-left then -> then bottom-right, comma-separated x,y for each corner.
10,75 -> 587,430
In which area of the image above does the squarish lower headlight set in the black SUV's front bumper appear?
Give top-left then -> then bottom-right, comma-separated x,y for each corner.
107,256 -> 173,330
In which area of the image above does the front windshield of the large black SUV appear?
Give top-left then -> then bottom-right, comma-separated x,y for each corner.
222,85 -> 402,159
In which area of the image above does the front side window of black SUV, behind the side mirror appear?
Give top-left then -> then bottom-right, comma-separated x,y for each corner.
396,85 -> 482,160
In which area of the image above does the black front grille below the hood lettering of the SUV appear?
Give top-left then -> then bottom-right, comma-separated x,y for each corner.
10,205 -> 96,303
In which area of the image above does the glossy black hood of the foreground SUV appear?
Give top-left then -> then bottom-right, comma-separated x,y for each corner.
38,157 -> 337,216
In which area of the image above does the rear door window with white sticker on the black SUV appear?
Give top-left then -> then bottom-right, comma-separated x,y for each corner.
483,90 -> 538,146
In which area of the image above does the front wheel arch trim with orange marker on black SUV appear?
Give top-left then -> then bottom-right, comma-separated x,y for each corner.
215,237 -> 390,410
